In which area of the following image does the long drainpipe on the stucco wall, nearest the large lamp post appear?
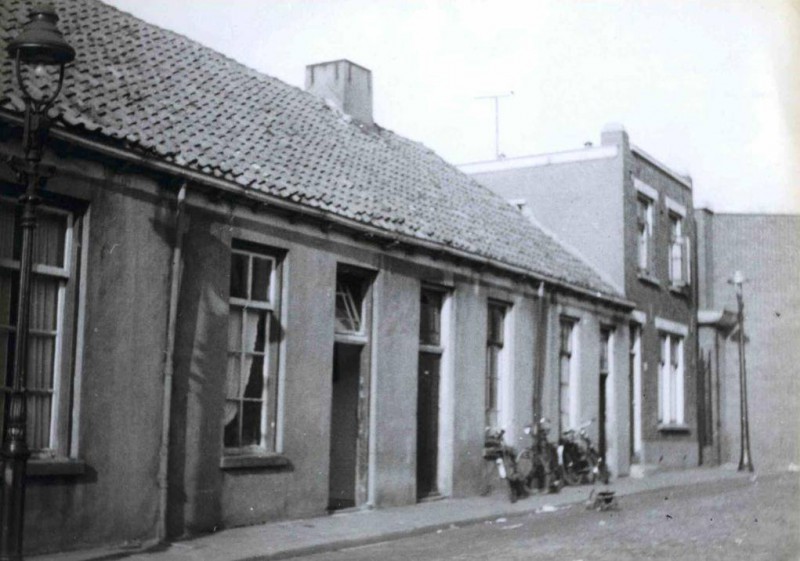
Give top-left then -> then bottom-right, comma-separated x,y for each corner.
156,182 -> 186,542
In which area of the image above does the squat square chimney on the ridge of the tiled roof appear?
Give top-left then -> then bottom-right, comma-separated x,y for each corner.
306,60 -> 374,125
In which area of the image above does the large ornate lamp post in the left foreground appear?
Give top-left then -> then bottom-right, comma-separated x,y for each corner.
0,5 -> 75,561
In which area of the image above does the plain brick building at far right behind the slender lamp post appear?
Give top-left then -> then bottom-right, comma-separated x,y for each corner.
695,209 -> 800,470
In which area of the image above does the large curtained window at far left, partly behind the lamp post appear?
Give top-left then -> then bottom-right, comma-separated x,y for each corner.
0,198 -> 82,458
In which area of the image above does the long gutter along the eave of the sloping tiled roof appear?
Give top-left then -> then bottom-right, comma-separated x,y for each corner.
0,111 -> 636,310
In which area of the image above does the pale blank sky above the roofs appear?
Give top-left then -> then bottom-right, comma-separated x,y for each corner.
106,0 -> 800,213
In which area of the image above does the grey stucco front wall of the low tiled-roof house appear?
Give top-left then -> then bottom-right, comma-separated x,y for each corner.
3,132 -> 630,551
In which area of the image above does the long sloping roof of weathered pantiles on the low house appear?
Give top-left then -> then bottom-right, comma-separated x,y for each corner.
0,0 -> 619,296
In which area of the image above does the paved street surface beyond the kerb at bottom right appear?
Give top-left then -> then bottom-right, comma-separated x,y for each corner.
296,473 -> 800,561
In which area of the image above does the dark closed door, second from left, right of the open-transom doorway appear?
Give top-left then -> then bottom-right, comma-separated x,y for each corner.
417,352 -> 441,499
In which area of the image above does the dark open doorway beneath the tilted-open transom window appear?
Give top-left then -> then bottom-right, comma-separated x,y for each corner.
328,343 -> 363,510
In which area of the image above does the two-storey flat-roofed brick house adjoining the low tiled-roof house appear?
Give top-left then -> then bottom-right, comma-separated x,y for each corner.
460,125 -> 699,471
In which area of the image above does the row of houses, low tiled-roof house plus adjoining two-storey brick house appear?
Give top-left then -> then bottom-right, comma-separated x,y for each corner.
0,0 -> 796,552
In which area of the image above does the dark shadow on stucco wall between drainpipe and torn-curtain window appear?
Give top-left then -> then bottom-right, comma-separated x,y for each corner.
157,211 -> 230,537
